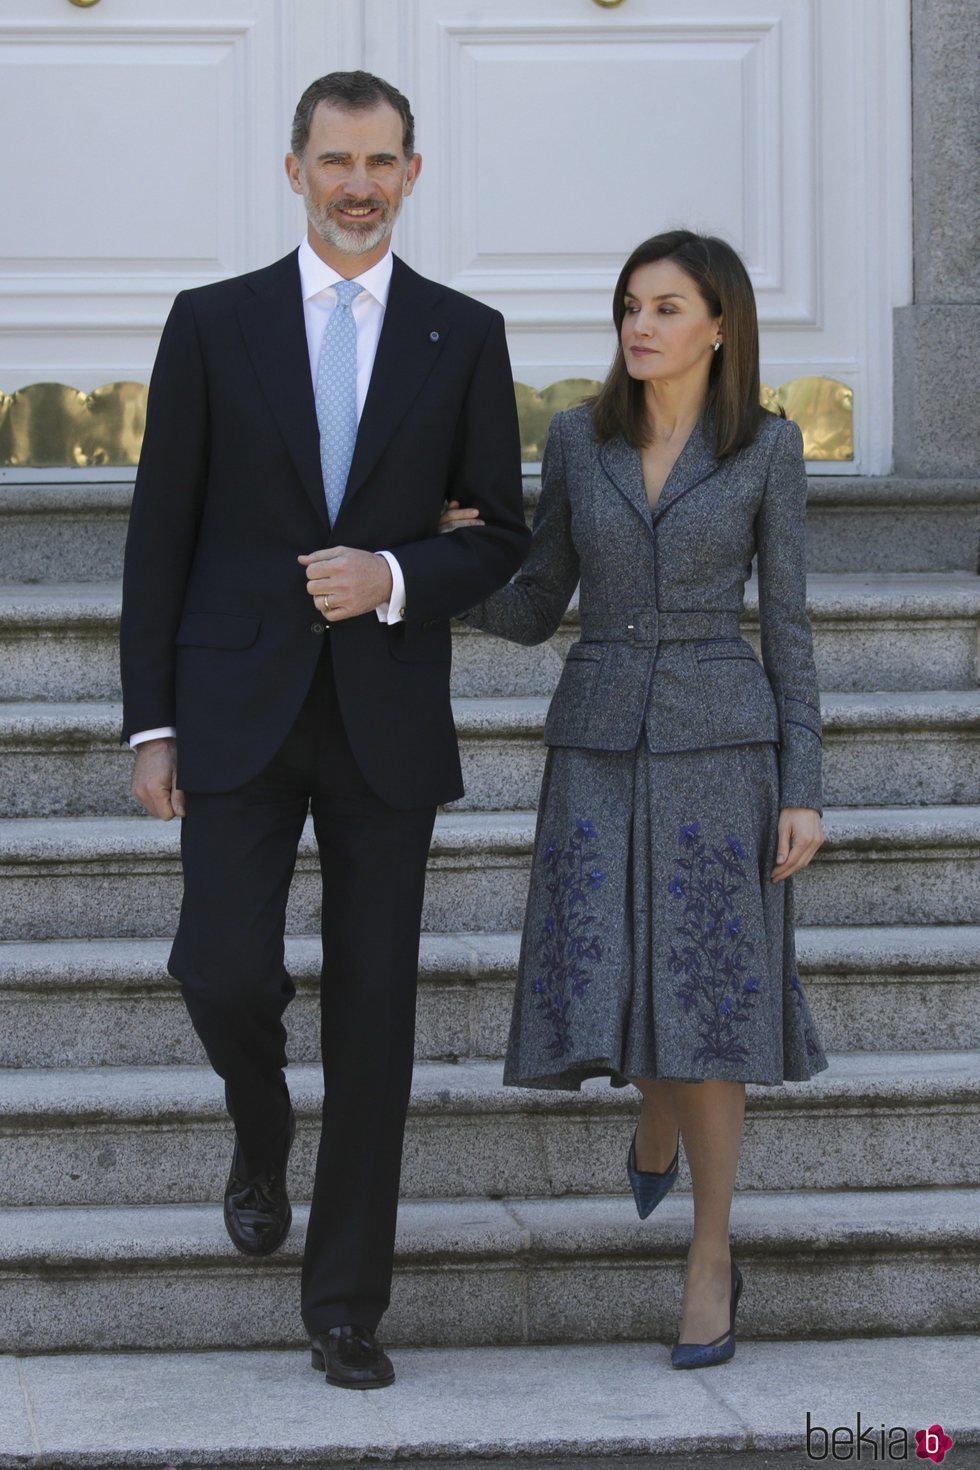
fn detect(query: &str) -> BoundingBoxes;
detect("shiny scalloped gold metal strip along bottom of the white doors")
[0,378,854,469]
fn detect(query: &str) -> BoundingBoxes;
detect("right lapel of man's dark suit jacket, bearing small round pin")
[338,256,447,519]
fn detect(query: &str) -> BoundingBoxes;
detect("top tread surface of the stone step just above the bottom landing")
[0,1188,980,1279]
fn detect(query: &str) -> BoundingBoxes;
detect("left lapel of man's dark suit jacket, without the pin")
[238,251,329,529]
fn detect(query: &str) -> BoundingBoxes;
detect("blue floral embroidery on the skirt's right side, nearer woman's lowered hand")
[667,822,760,1063]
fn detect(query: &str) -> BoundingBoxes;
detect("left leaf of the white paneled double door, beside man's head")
[0,0,302,391]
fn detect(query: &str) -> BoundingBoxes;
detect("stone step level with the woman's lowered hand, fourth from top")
[0,806,980,939]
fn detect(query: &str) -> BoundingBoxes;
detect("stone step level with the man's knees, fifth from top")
[0,925,980,1067]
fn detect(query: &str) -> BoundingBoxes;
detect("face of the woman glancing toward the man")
[620,260,721,382]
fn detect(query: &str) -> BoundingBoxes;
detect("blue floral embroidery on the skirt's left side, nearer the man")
[533,817,605,1057]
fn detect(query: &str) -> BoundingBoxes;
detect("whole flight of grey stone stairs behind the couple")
[0,476,980,1466]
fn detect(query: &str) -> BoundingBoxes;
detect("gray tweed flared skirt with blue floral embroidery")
[504,741,827,1089]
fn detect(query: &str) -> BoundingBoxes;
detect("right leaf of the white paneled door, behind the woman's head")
[363,0,911,473]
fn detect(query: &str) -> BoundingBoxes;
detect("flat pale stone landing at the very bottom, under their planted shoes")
[7,1340,980,1470]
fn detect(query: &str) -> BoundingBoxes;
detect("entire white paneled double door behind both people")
[0,0,911,473]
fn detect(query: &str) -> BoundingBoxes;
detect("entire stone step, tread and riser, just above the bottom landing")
[0,1189,980,1346]
